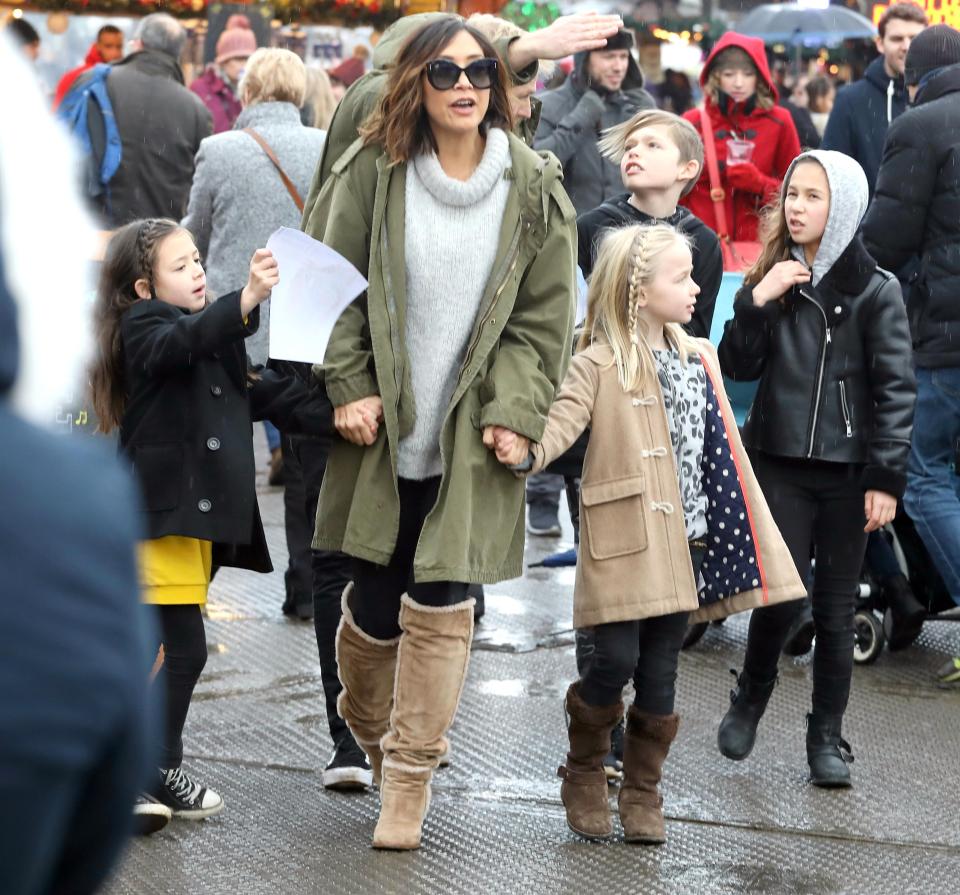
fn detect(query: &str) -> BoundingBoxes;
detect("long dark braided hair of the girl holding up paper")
[90,218,183,432]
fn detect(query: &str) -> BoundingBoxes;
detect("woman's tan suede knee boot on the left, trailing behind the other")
[336,583,400,786]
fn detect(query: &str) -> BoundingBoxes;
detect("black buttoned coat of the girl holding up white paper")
[120,292,332,572]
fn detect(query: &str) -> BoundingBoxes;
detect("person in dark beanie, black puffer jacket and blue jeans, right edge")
[863,25,960,673]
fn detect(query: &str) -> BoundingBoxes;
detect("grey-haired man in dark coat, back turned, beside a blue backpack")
[86,13,213,229]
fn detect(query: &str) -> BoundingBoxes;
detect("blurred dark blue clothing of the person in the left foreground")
[0,250,157,895]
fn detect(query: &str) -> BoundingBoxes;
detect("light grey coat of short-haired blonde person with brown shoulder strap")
[183,103,326,364]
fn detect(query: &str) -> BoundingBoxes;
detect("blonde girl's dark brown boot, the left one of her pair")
[557,683,623,839]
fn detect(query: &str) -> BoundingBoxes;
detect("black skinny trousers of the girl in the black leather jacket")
[744,453,867,715]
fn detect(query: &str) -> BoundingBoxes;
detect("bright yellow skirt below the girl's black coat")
[138,535,213,606]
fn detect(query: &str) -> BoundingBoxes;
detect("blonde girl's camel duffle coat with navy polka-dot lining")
[532,339,806,628]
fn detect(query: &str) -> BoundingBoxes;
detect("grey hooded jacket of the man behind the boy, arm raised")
[533,53,656,214]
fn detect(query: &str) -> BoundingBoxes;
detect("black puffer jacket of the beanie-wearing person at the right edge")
[863,65,960,367]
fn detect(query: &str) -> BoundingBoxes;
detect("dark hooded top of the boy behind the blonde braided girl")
[577,193,723,339]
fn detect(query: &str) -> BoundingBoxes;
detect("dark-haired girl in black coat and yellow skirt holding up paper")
[92,219,332,819]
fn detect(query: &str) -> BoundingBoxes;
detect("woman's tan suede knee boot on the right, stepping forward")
[373,594,474,849]
